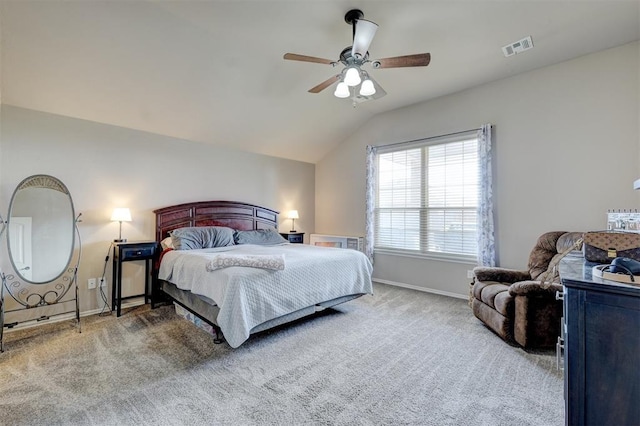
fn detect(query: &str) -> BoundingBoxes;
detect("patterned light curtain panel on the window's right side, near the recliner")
[478,124,496,266]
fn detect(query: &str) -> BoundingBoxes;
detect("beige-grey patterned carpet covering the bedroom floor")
[0,285,564,426]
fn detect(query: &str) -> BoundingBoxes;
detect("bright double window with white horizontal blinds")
[373,132,479,260]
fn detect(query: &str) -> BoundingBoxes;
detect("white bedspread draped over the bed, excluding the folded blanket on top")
[158,244,373,348]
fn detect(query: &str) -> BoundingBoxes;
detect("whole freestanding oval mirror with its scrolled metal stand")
[0,175,82,352]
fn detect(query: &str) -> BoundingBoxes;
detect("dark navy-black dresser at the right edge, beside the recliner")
[560,263,640,425]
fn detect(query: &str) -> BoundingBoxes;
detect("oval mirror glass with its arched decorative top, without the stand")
[7,175,75,284]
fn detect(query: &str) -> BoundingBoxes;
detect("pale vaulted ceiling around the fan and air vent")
[0,0,640,163]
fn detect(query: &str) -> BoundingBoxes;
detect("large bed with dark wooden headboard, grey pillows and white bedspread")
[151,201,373,348]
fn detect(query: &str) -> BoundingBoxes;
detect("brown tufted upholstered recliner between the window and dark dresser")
[471,231,582,348]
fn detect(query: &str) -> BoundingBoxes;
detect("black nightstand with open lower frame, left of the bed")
[111,241,158,316]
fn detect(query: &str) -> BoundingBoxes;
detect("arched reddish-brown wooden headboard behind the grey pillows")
[153,201,278,242]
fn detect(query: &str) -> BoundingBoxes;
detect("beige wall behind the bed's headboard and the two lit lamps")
[0,105,315,311]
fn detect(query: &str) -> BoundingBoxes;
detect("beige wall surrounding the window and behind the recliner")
[316,42,640,297]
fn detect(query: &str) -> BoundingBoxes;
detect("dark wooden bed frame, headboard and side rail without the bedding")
[151,201,278,343]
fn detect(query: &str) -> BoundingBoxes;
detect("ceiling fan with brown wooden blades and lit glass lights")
[284,9,431,106]
